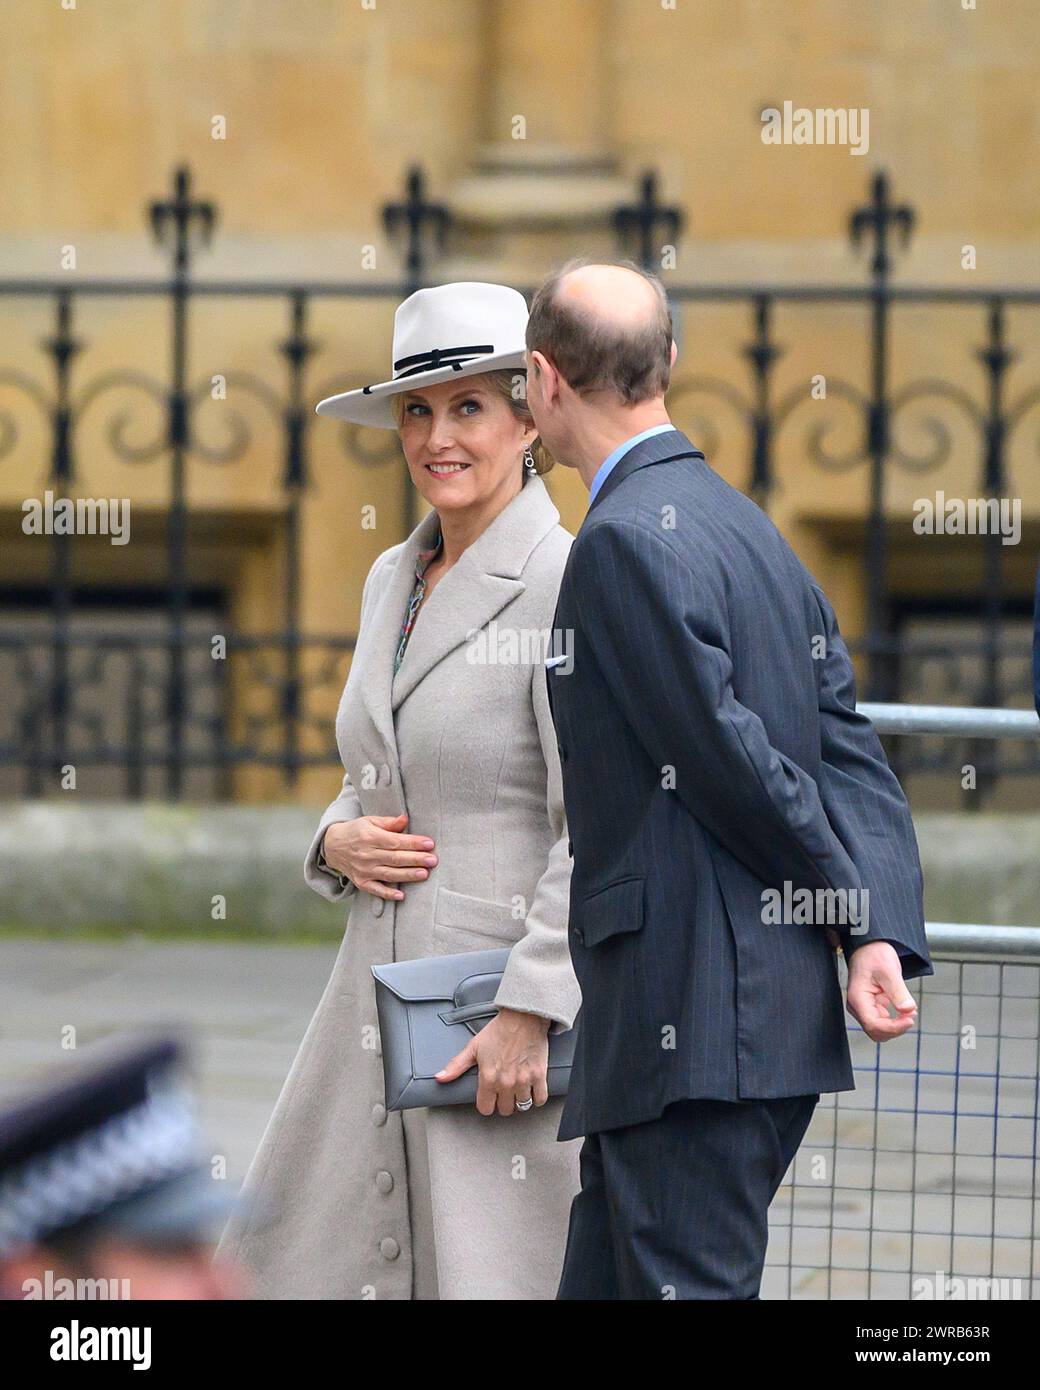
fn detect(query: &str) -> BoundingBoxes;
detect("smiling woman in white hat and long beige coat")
[220,284,580,1298]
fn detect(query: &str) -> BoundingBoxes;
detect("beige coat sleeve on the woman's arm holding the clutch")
[495,644,581,1033]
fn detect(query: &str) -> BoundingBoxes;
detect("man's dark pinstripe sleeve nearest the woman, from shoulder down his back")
[571,521,859,891]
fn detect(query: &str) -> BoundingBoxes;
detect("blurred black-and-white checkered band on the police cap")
[0,1088,197,1258]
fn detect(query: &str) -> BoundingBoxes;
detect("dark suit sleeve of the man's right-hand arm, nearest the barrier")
[813,587,933,980]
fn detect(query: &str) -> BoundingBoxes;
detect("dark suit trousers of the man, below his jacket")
[556,1095,819,1300]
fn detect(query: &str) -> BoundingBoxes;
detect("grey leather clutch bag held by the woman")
[373,947,576,1111]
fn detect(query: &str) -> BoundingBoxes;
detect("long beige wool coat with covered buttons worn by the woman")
[218,475,580,1298]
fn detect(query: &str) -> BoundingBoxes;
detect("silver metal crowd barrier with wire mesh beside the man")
[762,705,1040,1302]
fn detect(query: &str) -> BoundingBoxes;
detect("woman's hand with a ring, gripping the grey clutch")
[437,1009,551,1115]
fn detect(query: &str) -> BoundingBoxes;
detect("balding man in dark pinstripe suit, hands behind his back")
[527,263,932,1298]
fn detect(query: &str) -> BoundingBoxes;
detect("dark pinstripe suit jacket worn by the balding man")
[546,431,932,1138]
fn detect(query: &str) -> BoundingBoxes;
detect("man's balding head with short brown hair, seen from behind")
[527,260,672,404]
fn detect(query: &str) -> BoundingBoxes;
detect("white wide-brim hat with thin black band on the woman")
[314,281,527,430]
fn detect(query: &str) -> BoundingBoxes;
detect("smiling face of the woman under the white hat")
[398,375,535,510]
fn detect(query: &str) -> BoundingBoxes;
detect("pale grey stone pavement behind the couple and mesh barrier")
[0,937,1040,1300]
